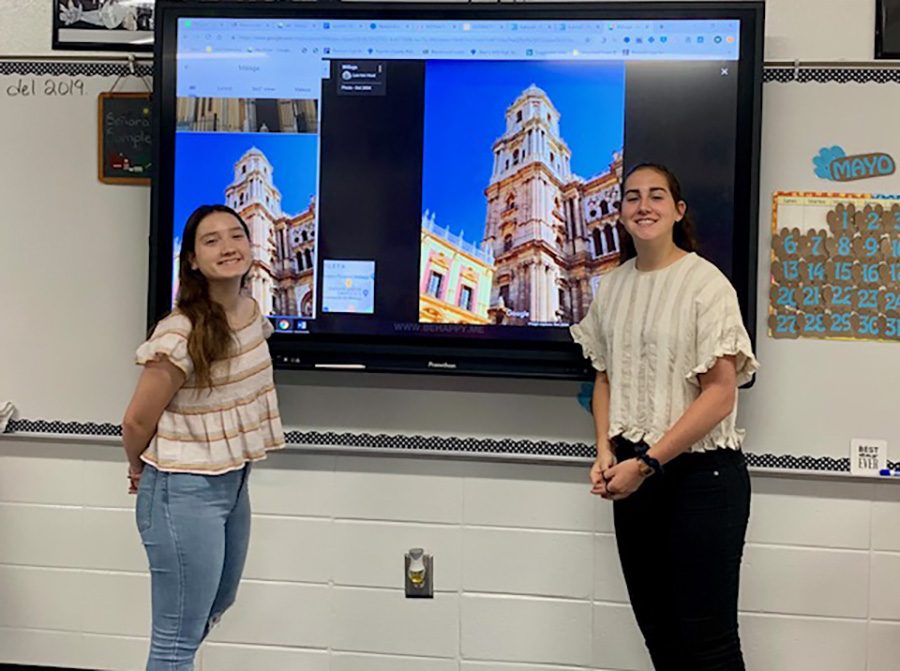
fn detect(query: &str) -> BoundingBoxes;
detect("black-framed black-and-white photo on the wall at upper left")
[52,0,156,51]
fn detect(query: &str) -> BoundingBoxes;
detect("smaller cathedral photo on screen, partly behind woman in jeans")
[172,125,319,317]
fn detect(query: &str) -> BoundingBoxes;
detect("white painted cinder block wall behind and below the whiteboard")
[0,0,900,671]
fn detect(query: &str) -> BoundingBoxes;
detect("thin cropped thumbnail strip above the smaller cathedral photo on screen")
[175,97,319,133]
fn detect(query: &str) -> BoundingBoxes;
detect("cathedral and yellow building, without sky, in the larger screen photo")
[419,84,624,325]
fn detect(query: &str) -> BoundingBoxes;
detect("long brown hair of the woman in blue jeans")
[175,205,250,389]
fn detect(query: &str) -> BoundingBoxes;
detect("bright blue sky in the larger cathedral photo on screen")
[422,61,625,244]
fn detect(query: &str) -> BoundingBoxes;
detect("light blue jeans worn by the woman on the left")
[136,464,250,671]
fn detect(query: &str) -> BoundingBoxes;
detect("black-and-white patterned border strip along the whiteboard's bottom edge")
[4,419,900,473]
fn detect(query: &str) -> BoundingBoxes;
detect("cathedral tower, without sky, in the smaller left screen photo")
[225,147,316,317]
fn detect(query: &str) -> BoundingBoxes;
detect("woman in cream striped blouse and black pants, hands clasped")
[571,164,758,671]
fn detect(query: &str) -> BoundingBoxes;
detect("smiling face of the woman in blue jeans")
[191,212,252,282]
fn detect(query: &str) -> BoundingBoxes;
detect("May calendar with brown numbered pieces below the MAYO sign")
[769,192,900,342]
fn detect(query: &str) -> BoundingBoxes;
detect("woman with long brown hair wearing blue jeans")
[122,205,284,671]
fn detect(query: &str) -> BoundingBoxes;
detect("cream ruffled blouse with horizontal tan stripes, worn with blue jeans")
[136,306,285,475]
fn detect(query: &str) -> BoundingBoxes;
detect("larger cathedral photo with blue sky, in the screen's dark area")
[419,62,624,326]
